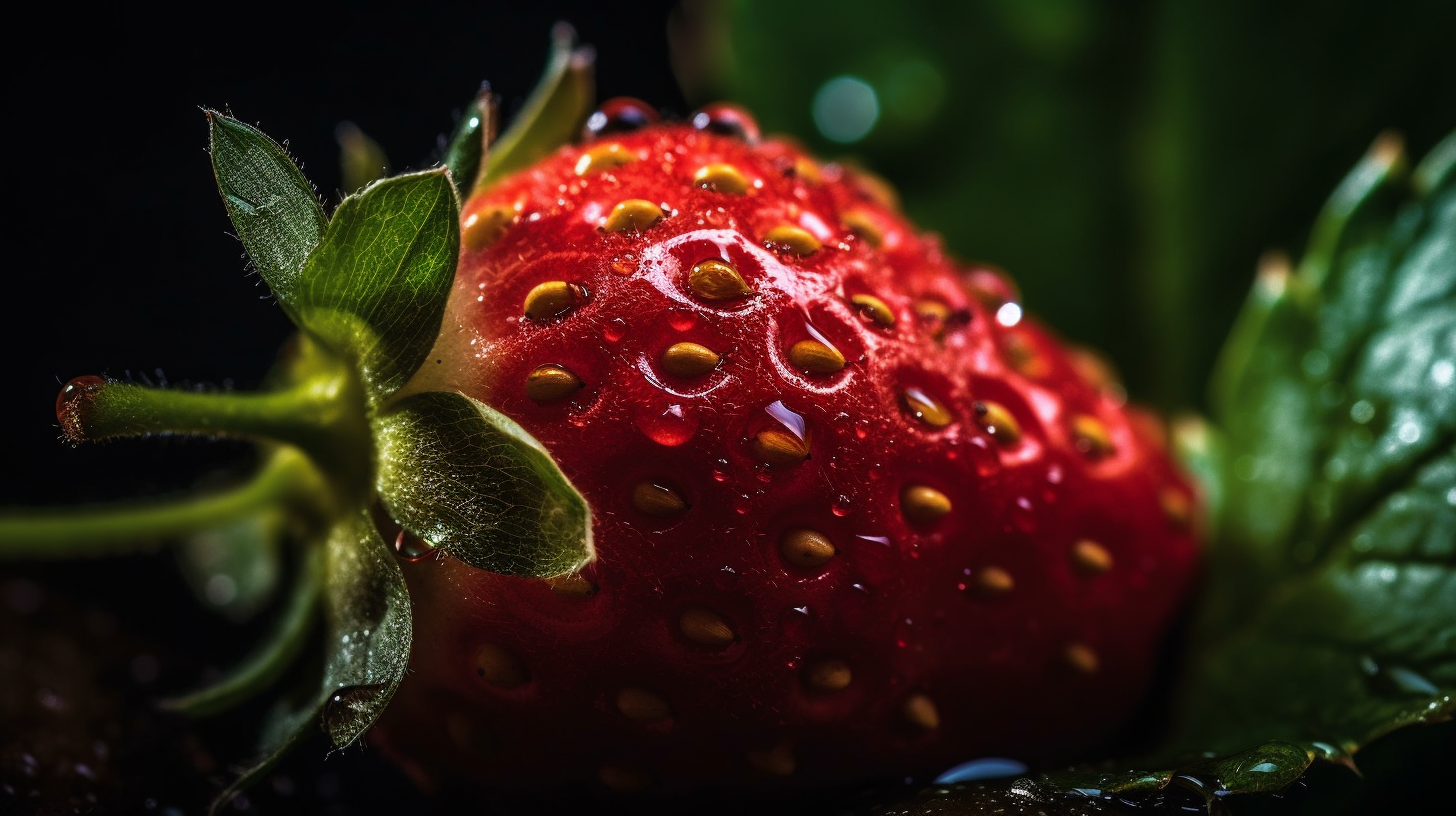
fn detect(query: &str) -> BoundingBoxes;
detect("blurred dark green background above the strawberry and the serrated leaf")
[674,0,1456,409]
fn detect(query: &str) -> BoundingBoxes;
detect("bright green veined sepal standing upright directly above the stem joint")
[287,169,460,402]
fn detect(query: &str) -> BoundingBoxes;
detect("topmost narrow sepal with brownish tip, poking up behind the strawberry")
[473,23,596,191]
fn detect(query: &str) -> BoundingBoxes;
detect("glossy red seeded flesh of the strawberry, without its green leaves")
[371,101,1197,790]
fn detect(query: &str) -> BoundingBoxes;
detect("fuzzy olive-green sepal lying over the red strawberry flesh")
[376,392,594,577]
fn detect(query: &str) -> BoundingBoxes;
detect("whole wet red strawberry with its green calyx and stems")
[0,32,1197,799]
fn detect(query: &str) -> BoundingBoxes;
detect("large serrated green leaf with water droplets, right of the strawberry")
[1174,137,1456,757]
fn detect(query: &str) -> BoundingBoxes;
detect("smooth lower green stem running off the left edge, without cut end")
[0,447,333,560]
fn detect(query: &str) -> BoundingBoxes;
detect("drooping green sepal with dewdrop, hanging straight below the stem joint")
[211,510,412,813]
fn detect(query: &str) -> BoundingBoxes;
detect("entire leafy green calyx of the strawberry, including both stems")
[0,26,594,807]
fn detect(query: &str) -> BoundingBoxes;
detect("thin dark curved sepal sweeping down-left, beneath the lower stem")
[162,546,326,717]
